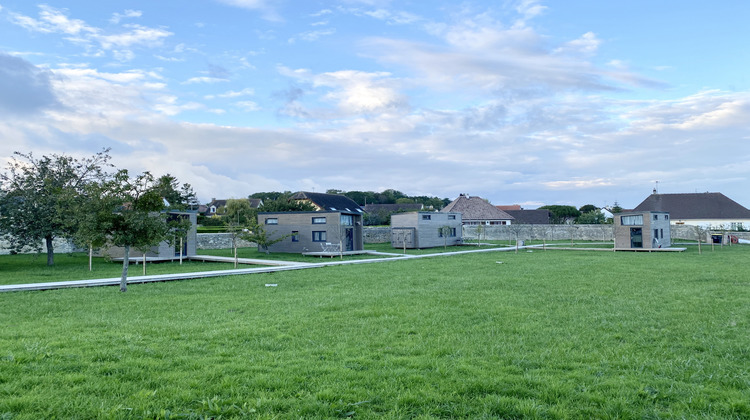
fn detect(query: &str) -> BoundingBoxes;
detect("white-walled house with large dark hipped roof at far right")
[633,192,750,230]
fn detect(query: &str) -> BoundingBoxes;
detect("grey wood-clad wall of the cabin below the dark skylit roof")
[258,211,364,253]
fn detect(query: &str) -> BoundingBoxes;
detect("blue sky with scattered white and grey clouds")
[0,0,750,209]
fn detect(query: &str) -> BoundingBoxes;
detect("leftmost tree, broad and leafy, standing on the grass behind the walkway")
[0,149,111,265]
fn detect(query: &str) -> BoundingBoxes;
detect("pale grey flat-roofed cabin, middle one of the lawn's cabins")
[391,211,463,249]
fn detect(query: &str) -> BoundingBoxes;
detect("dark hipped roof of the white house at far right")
[633,192,750,220]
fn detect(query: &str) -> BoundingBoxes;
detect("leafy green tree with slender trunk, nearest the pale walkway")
[79,169,174,292]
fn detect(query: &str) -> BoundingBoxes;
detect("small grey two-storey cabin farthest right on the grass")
[614,211,672,250]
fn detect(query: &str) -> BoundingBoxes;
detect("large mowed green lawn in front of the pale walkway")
[0,246,750,419]
